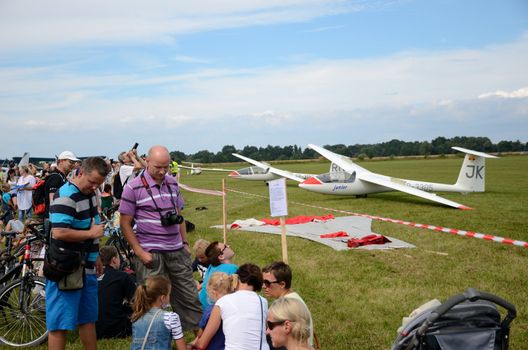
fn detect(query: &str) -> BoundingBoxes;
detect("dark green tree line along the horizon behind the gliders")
[171,136,528,163]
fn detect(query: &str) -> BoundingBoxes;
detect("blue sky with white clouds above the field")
[0,0,528,159]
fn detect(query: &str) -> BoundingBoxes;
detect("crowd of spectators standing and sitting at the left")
[0,146,318,350]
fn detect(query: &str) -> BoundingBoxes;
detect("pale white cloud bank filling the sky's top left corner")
[0,0,366,51]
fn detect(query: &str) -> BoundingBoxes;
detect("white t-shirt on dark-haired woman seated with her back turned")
[215,290,269,350]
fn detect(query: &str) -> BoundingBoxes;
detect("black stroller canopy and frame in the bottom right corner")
[392,288,517,350]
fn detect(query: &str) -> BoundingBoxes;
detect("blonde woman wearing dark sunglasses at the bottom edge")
[266,298,311,350]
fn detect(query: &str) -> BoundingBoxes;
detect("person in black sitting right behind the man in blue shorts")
[95,246,136,339]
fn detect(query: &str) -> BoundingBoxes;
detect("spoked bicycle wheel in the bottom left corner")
[0,276,48,347]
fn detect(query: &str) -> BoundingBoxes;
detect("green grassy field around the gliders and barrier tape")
[20,156,528,349]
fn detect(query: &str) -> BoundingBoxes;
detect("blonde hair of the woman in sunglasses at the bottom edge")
[268,297,311,344]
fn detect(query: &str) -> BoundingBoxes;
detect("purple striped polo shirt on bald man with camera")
[119,170,183,251]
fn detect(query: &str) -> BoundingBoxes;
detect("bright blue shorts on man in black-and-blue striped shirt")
[46,274,98,331]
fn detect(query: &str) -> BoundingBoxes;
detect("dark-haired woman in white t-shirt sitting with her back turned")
[194,263,269,350]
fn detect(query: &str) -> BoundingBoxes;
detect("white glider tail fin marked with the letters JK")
[453,147,497,192]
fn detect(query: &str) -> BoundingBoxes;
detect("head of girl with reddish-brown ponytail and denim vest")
[131,275,171,322]
